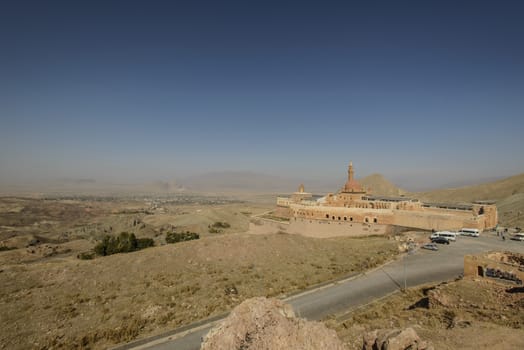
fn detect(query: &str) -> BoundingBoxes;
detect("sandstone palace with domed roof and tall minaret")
[275,163,498,236]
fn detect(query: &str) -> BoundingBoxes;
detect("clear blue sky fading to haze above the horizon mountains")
[0,0,524,191]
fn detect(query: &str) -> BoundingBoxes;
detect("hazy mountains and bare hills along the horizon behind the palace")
[0,171,524,227]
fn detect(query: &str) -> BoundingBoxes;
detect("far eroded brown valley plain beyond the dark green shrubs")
[0,195,273,263]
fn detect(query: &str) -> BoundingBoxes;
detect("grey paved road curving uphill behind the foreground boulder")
[116,233,524,350]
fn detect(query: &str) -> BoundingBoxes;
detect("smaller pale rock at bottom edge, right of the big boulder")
[362,328,434,350]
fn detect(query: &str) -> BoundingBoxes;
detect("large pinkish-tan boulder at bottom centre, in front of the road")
[201,297,345,350]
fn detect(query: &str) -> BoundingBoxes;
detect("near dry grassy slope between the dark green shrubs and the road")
[0,234,397,349]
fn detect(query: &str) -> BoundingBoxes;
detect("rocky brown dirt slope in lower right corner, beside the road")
[326,279,524,350]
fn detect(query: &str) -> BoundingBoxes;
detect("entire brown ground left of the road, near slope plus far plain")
[0,198,398,349]
